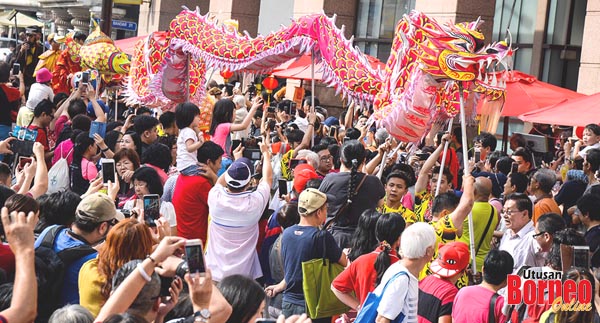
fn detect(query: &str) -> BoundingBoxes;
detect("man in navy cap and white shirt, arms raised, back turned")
[206,143,273,281]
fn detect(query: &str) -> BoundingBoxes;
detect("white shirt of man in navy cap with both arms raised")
[206,181,271,281]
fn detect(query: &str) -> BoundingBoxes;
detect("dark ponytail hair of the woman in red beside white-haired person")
[374,213,406,287]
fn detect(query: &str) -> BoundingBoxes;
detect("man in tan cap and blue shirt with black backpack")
[35,193,123,306]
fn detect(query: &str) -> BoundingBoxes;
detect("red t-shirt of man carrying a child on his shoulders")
[172,175,212,242]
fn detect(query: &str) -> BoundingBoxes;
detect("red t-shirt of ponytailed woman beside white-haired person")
[328,248,399,304]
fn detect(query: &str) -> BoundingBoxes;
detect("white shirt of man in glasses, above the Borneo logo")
[499,221,539,274]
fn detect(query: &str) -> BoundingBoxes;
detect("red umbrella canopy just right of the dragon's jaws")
[477,71,584,117]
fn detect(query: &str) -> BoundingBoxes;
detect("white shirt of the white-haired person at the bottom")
[374,261,419,323]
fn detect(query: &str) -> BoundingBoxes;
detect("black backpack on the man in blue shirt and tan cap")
[35,225,96,323]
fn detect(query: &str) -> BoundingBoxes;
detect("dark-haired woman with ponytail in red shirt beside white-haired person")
[331,213,406,311]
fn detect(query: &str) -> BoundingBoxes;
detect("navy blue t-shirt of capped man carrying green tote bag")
[281,224,342,306]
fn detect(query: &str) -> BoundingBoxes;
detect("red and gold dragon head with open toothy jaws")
[409,13,513,95]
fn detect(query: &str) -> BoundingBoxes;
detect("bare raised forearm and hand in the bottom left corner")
[0,207,38,323]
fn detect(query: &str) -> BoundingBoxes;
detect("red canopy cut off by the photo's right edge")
[519,93,600,127]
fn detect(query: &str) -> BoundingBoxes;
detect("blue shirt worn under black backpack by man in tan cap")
[34,225,98,306]
